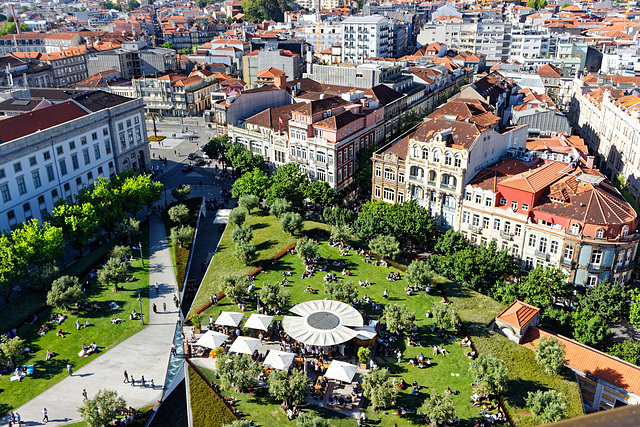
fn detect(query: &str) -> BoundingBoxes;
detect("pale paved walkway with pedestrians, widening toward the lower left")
[0,219,178,426]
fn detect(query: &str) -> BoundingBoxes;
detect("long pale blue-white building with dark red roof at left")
[0,91,150,230]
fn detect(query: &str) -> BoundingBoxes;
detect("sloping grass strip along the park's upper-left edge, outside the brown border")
[189,209,331,315]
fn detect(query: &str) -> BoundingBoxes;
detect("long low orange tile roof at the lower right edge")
[523,327,640,395]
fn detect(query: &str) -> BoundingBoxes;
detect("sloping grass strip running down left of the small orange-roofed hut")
[442,280,583,426]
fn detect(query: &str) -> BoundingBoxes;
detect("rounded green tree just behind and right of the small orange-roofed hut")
[518,266,571,310]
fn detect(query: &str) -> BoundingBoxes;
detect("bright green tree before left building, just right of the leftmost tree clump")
[52,202,98,251]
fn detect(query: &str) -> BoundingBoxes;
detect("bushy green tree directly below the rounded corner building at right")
[578,280,629,322]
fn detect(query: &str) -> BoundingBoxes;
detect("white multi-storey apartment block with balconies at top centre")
[342,15,394,63]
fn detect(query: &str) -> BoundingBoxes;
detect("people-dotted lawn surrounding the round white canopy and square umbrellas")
[198,239,488,426]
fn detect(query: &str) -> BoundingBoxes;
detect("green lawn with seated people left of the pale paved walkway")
[0,226,149,415]
